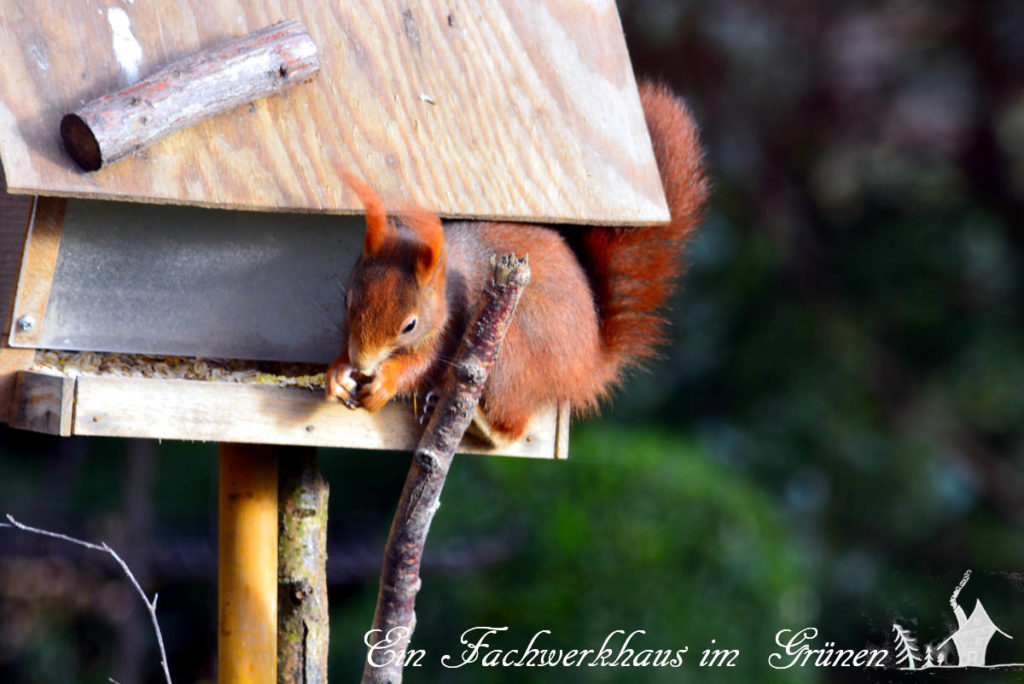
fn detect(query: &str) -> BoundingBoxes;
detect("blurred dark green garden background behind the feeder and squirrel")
[0,0,1024,683]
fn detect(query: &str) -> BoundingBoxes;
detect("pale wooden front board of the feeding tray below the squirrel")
[64,376,558,459]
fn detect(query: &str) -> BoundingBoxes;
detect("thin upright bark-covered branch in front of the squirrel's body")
[362,254,529,684]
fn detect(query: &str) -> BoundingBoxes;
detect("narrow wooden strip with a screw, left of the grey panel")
[9,198,68,347]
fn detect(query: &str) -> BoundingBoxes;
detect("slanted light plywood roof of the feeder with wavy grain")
[0,0,668,224]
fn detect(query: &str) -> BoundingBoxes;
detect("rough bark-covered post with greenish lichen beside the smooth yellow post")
[278,446,330,684]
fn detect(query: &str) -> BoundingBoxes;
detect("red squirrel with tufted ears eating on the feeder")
[327,83,708,442]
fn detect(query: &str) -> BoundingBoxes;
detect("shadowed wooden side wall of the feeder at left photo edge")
[0,188,35,423]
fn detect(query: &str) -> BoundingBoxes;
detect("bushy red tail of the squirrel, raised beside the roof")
[582,82,708,384]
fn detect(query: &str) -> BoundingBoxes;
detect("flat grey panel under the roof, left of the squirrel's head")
[39,200,364,364]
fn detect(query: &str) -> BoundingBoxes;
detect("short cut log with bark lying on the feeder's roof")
[60,19,319,171]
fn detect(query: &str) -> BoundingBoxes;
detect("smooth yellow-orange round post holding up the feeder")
[217,444,278,684]
